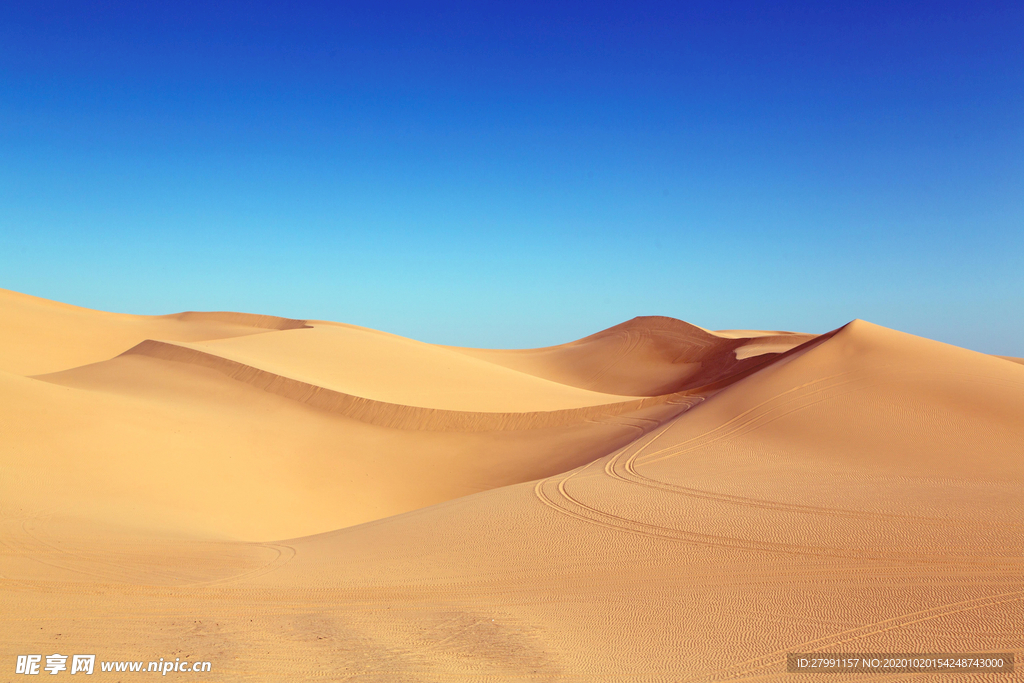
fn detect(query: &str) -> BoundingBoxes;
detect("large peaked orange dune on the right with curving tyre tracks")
[232,322,1024,681]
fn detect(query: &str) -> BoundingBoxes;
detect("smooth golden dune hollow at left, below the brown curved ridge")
[6,354,686,540]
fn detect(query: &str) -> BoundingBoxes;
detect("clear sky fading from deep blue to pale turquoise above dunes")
[0,0,1024,355]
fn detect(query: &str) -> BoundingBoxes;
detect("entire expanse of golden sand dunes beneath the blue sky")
[0,290,1024,683]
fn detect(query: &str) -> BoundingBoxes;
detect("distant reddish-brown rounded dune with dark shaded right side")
[452,316,814,396]
